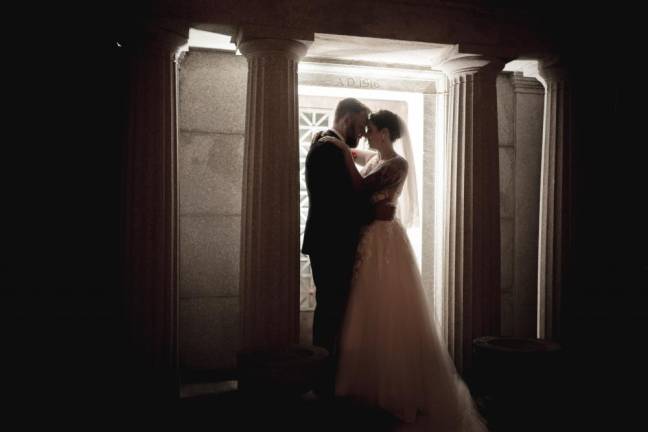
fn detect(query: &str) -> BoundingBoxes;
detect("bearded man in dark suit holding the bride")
[302,98,394,396]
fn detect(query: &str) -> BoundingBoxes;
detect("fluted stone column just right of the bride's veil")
[440,55,504,370]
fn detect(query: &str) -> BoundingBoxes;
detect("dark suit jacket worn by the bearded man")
[302,130,373,255]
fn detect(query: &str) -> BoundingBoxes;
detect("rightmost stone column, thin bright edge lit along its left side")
[538,59,573,340]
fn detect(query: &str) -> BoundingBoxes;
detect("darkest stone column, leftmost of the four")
[123,22,188,398]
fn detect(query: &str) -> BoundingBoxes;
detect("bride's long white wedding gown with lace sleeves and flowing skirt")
[336,156,487,432]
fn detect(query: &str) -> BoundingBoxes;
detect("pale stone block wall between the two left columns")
[178,50,247,369]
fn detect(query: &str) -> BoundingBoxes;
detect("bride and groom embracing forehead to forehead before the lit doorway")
[302,98,487,432]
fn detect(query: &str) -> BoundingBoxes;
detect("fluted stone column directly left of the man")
[239,39,306,349]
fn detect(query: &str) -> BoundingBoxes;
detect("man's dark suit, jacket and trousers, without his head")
[302,130,373,392]
